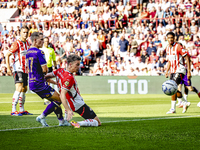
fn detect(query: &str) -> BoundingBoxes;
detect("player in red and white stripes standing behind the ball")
[165,32,191,114]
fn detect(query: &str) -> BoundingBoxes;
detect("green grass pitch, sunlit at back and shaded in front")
[0,94,200,150]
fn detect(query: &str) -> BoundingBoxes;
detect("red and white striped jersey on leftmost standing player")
[9,40,30,73]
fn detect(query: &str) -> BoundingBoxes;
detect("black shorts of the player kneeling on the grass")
[75,104,97,119]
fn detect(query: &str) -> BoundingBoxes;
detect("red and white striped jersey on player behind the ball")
[166,43,187,73]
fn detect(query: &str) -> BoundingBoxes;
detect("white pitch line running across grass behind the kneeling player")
[0,115,200,132]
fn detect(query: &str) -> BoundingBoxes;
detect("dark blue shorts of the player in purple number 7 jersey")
[33,85,55,99]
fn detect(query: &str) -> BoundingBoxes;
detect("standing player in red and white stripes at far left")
[6,26,32,116]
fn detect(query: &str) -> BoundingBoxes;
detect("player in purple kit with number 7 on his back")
[26,32,73,127]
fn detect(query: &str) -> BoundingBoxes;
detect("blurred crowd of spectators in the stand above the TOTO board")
[0,0,200,76]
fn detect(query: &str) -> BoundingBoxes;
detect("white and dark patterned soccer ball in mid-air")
[162,80,178,96]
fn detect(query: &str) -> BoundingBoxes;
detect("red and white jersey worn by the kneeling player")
[53,68,85,111]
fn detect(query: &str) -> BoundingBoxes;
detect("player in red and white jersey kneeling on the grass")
[45,54,101,128]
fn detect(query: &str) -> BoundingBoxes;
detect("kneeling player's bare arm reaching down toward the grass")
[60,89,74,121]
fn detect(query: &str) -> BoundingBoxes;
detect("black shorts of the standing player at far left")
[13,71,28,86]
